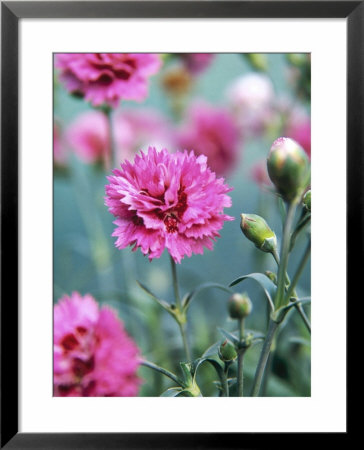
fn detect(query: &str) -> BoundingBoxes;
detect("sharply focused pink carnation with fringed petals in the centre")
[105,147,233,263]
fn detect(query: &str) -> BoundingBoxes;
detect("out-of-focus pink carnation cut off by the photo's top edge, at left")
[55,53,161,107]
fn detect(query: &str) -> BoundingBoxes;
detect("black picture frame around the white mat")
[1,1,356,449]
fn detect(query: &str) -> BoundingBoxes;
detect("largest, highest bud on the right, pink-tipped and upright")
[267,137,310,201]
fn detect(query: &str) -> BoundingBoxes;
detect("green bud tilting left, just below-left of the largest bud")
[240,214,277,253]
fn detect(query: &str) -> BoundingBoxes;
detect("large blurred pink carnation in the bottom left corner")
[53,292,140,397]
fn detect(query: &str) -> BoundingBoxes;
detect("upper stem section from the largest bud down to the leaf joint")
[275,200,297,309]
